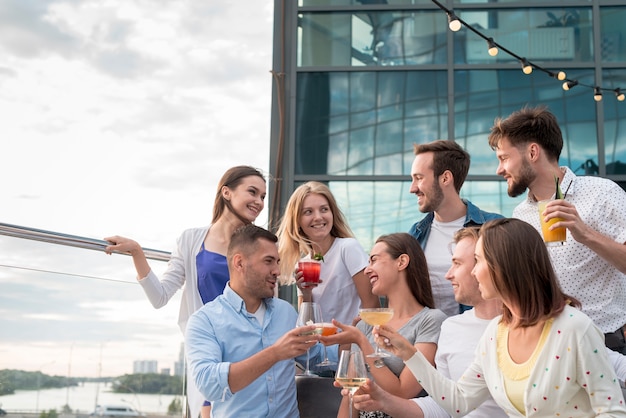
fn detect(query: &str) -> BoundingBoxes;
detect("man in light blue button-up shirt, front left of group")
[185,225,321,418]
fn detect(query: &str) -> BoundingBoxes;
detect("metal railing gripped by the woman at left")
[0,222,171,261]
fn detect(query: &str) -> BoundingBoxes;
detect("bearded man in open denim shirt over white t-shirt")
[409,140,502,316]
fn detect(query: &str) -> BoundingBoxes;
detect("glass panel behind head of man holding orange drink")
[454,70,598,175]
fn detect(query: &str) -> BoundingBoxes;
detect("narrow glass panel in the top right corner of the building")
[600,7,626,62]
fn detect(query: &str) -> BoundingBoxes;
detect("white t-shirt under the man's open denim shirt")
[424,216,465,316]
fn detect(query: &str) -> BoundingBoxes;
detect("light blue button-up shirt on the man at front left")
[185,284,314,418]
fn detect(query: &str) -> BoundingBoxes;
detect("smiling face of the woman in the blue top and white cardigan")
[222,176,267,222]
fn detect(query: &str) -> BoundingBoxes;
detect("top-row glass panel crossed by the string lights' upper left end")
[454,7,588,63]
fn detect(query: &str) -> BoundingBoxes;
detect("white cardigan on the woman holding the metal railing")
[139,226,210,418]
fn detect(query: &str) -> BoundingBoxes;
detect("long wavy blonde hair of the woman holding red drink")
[277,181,354,284]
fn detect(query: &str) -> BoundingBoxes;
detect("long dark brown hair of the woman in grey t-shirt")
[376,232,435,309]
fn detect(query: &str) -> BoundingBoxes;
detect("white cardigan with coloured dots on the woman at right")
[406,306,626,418]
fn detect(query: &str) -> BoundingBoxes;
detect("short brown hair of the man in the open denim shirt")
[413,139,470,193]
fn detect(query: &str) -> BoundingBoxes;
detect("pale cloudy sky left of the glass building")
[0,0,273,377]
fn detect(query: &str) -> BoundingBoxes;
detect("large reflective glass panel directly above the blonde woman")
[295,71,448,176]
